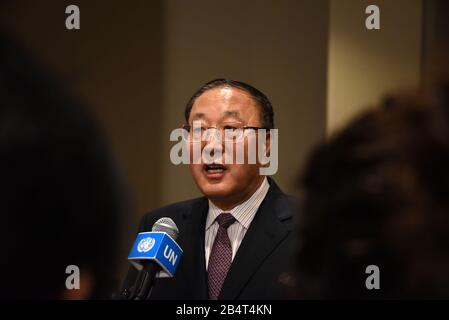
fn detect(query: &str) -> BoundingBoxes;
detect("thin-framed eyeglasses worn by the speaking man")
[182,123,266,142]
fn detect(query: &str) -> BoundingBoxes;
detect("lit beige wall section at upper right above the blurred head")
[326,0,423,134]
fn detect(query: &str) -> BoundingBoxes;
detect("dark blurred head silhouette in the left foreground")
[0,34,122,299]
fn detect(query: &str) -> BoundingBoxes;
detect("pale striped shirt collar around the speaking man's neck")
[206,177,270,230]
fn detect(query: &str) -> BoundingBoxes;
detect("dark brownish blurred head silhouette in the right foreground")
[297,82,449,299]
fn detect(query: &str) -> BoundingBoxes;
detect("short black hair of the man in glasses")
[184,79,274,129]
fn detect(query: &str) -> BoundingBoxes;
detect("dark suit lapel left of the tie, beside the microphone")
[183,198,209,299]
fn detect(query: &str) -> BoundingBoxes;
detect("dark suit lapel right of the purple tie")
[219,179,291,300]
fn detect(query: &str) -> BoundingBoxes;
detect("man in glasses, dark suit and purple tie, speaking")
[117,79,295,300]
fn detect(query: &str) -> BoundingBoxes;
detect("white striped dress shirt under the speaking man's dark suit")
[204,178,270,270]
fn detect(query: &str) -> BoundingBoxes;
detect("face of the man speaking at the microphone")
[189,87,263,205]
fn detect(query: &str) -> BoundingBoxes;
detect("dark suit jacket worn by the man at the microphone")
[118,178,295,300]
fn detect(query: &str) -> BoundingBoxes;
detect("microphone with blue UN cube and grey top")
[128,217,183,300]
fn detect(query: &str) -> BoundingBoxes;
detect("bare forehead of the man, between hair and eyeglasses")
[190,86,260,122]
